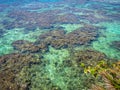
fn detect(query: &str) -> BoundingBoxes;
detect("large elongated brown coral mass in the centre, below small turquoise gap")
[35,25,99,48]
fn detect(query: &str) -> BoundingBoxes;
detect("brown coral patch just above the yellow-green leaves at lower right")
[66,50,107,66]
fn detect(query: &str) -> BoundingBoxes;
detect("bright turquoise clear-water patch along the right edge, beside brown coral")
[92,22,120,59]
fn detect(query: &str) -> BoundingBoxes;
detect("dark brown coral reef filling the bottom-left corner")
[0,53,41,90]
